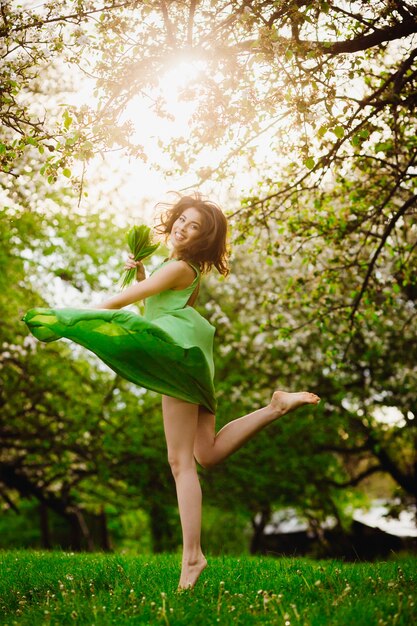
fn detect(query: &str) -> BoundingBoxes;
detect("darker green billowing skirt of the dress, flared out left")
[23,308,216,413]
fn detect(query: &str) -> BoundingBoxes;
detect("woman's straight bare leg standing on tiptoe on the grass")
[162,396,207,589]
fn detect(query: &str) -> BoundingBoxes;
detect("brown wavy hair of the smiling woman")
[155,192,229,276]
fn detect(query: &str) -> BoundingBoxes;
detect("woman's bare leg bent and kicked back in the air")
[194,391,320,467]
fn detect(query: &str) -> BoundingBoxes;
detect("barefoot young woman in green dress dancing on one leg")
[24,194,319,589]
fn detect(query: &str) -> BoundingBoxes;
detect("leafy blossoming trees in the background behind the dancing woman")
[0,0,417,549]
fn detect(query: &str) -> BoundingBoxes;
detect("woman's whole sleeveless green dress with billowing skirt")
[23,259,216,413]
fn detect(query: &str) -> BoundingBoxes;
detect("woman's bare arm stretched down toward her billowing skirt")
[94,261,194,309]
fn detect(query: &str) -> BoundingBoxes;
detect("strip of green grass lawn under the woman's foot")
[0,551,417,626]
